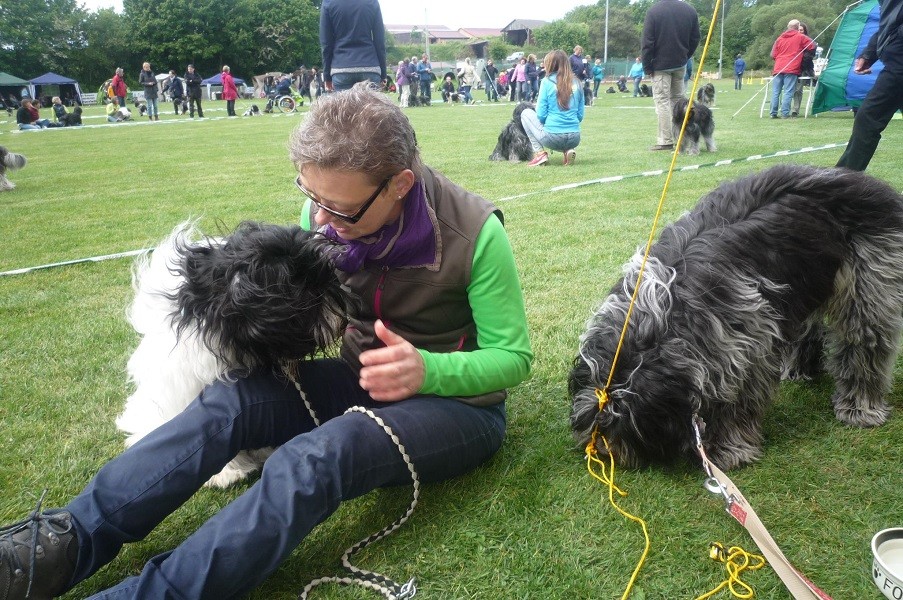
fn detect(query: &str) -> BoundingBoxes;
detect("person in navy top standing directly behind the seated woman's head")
[320,0,386,92]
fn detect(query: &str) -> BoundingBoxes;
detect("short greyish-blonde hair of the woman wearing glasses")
[289,82,423,184]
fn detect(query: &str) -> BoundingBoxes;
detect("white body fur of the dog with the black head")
[116,223,273,487]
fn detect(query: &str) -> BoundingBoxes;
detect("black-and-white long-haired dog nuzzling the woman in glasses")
[122,222,353,487]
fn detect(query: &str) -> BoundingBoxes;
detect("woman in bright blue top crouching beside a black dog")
[520,50,584,167]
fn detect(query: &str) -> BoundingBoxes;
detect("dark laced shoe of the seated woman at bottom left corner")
[0,496,78,600]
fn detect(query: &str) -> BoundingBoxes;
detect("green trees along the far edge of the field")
[0,0,849,88]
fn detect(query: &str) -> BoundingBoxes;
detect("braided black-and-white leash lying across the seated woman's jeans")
[292,369,420,600]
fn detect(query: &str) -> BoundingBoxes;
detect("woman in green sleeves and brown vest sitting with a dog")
[0,83,533,600]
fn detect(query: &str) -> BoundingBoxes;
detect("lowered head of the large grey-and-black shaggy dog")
[568,257,695,468]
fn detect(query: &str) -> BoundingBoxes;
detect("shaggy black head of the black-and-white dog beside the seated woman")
[172,221,354,368]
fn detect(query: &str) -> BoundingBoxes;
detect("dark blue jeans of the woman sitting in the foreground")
[66,359,505,600]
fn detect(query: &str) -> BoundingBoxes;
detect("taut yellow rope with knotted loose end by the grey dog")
[586,0,728,600]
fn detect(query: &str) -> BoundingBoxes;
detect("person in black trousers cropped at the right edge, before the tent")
[837,0,903,171]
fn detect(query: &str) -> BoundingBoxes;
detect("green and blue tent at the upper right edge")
[812,0,884,114]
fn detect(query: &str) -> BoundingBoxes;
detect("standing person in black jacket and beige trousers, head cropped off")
[641,0,699,150]
